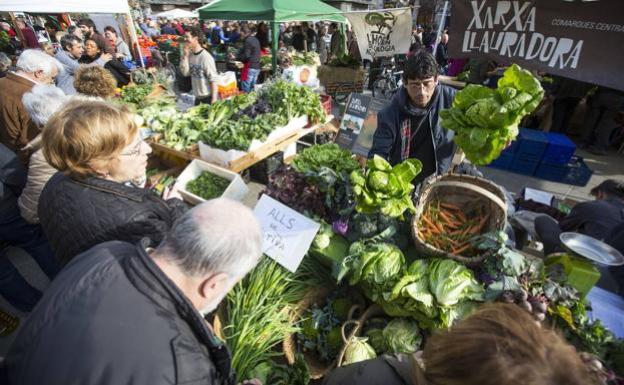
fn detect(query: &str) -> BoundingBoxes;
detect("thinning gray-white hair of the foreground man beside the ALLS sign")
[157,198,262,278]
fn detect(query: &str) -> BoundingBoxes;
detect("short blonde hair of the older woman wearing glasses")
[42,100,138,177]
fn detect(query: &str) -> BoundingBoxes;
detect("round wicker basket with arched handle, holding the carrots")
[412,174,507,266]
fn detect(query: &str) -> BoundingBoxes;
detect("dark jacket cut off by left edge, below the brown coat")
[0,143,27,222]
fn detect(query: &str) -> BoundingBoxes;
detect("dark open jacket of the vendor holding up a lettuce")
[368,84,457,173]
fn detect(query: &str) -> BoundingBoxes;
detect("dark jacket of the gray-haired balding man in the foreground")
[4,242,234,385]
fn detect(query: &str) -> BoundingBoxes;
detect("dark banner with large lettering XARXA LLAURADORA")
[448,0,624,90]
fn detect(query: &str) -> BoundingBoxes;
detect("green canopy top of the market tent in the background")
[197,0,346,23]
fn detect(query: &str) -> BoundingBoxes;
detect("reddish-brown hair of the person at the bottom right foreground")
[414,303,595,385]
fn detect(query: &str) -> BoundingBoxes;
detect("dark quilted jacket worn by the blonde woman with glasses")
[38,173,186,264]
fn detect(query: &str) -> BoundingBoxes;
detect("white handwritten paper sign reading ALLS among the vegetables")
[254,195,320,273]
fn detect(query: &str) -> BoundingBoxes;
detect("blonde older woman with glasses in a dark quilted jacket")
[38,101,186,264]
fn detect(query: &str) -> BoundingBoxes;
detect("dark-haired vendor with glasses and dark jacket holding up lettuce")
[368,51,456,184]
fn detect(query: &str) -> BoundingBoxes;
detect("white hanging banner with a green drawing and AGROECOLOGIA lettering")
[344,8,412,60]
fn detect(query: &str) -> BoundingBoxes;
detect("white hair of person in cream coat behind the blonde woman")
[22,84,68,127]
